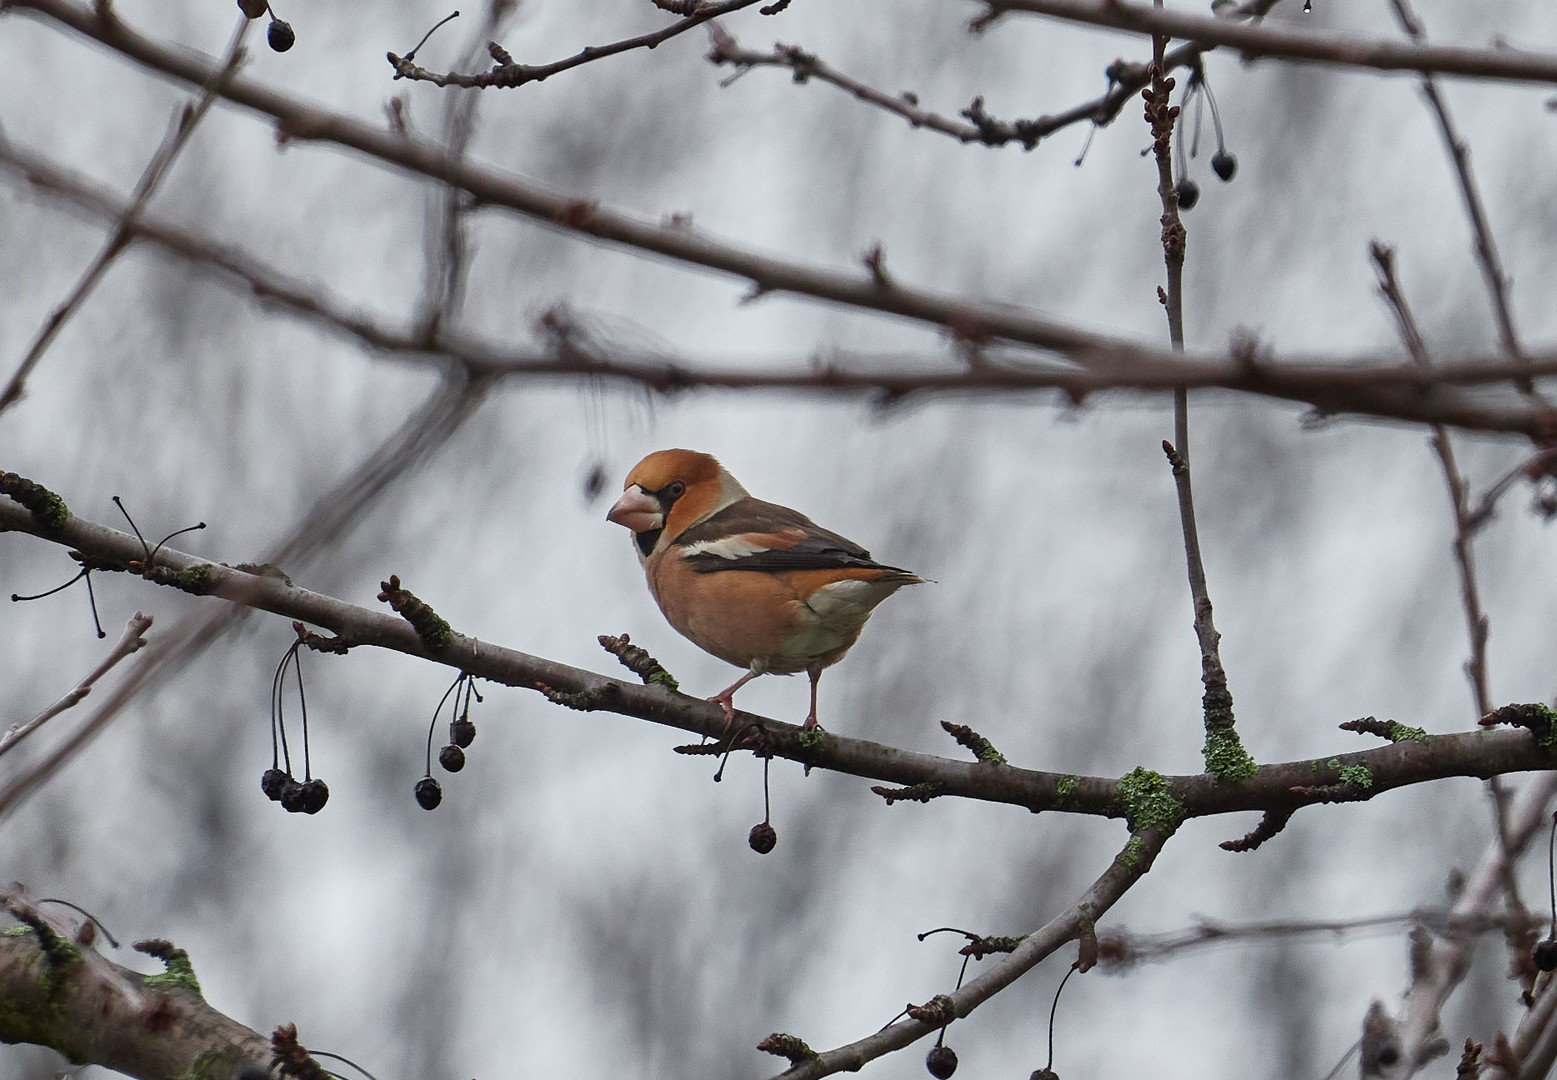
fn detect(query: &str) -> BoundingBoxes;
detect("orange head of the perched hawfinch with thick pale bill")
[606,450,747,559]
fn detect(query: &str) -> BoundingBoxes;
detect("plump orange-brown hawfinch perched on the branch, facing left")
[606,450,925,728]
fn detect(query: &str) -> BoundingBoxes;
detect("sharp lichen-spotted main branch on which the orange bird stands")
[9,498,1557,825]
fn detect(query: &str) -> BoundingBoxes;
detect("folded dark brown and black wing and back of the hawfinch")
[676,498,908,574]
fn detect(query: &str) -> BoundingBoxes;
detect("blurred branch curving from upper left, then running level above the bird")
[0,137,1557,437]
